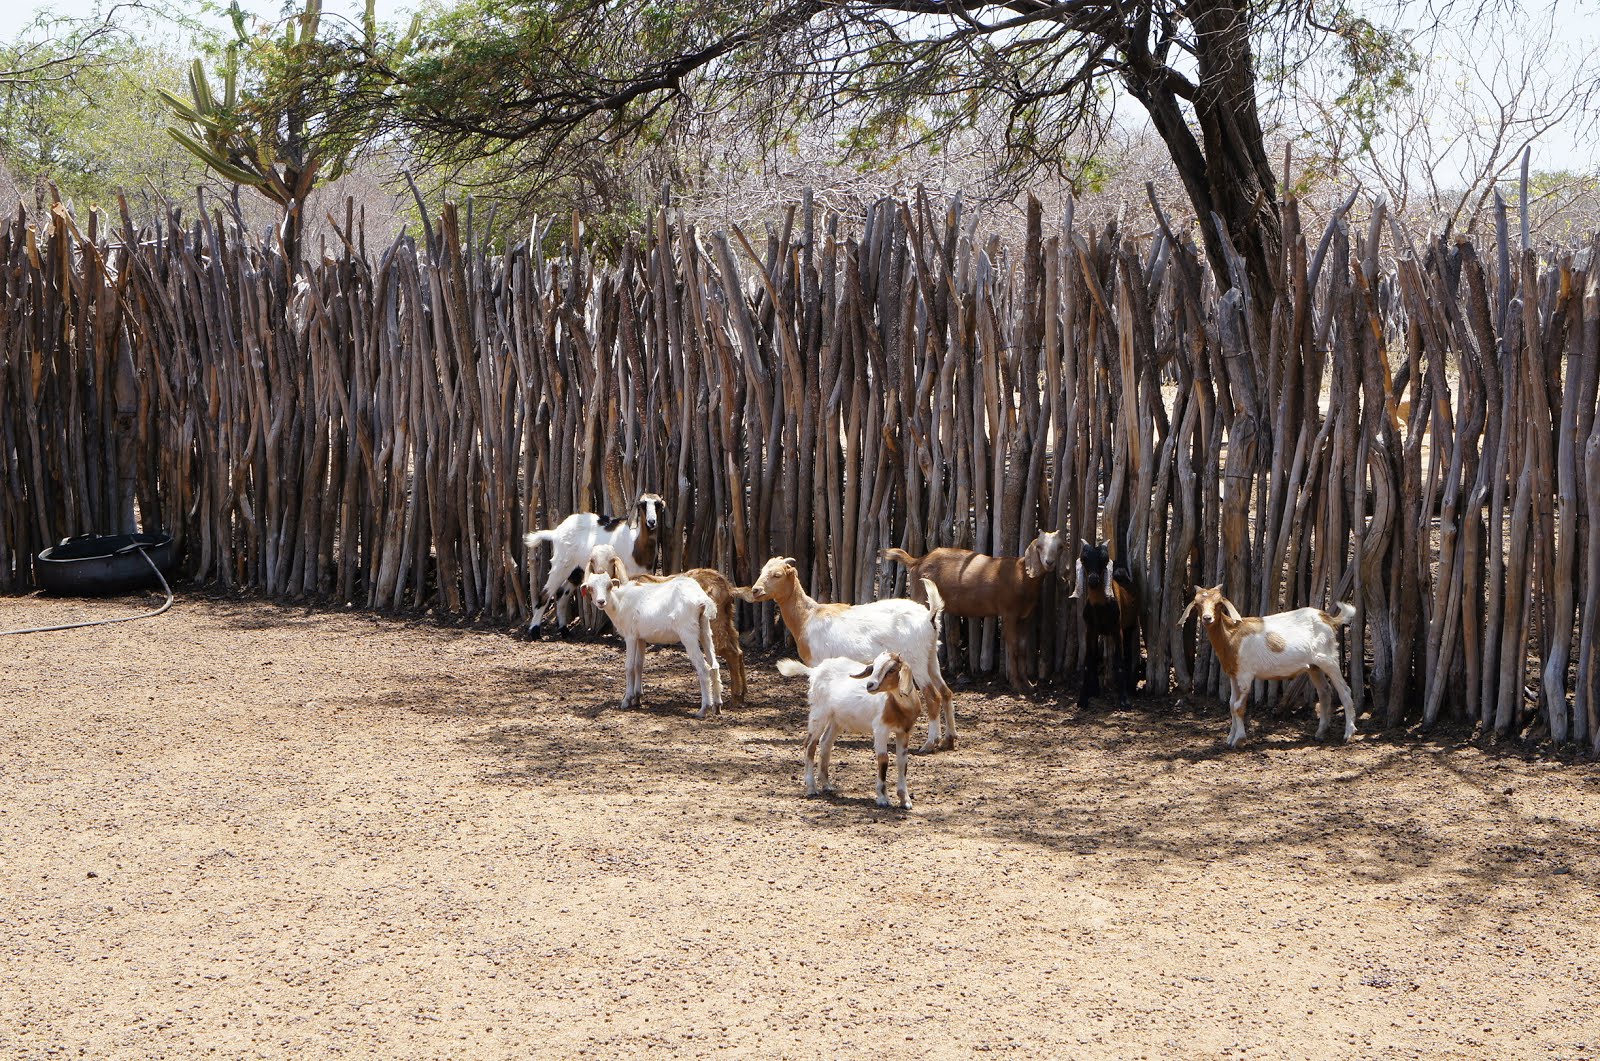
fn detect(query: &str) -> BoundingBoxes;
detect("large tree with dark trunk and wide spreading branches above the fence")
[363,0,1427,299]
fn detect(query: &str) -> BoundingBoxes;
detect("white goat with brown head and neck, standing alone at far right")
[1178,584,1355,747]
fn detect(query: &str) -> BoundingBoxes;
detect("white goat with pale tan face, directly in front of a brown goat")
[582,557,722,719]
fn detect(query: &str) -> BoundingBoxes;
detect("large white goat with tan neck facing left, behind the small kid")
[750,557,955,752]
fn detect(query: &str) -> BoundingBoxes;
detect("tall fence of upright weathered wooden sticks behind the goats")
[0,195,1600,749]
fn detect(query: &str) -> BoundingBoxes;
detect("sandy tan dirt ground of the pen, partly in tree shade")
[0,594,1600,1058]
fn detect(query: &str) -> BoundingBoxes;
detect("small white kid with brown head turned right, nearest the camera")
[778,651,922,810]
